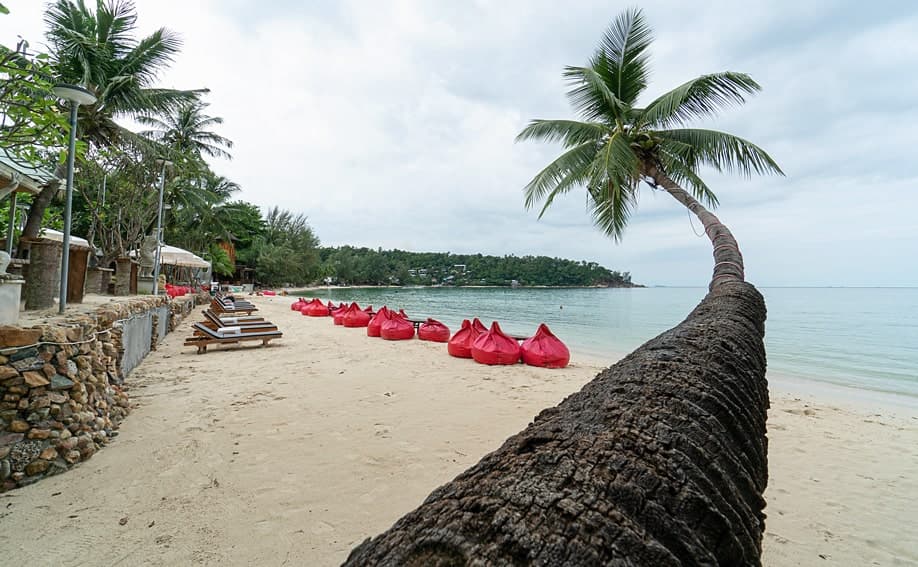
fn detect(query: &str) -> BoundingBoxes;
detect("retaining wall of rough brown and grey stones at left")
[0,296,210,492]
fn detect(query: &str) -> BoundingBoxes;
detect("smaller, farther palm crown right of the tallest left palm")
[137,100,233,159]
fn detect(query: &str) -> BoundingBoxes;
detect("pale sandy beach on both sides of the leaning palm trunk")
[0,297,918,565]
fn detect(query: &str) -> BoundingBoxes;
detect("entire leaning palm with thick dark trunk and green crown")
[346,11,780,566]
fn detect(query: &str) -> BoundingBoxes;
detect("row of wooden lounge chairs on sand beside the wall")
[185,296,284,354]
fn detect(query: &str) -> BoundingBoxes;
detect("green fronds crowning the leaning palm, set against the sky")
[517,10,783,240]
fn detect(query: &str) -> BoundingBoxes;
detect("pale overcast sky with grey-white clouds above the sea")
[0,0,918,286]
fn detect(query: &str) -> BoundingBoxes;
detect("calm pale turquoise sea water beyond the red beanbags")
[306,288,918,404]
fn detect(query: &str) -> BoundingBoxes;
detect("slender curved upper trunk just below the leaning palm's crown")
[645,166,745,290]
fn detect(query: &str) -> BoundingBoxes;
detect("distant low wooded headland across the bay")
[319,246,633,287]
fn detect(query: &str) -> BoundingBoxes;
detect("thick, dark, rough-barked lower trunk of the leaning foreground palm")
[346,278,769,566]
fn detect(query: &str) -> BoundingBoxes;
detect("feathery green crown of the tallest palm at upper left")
[45,0,206,149]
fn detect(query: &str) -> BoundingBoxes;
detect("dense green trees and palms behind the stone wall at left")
[0,0,320,284]
